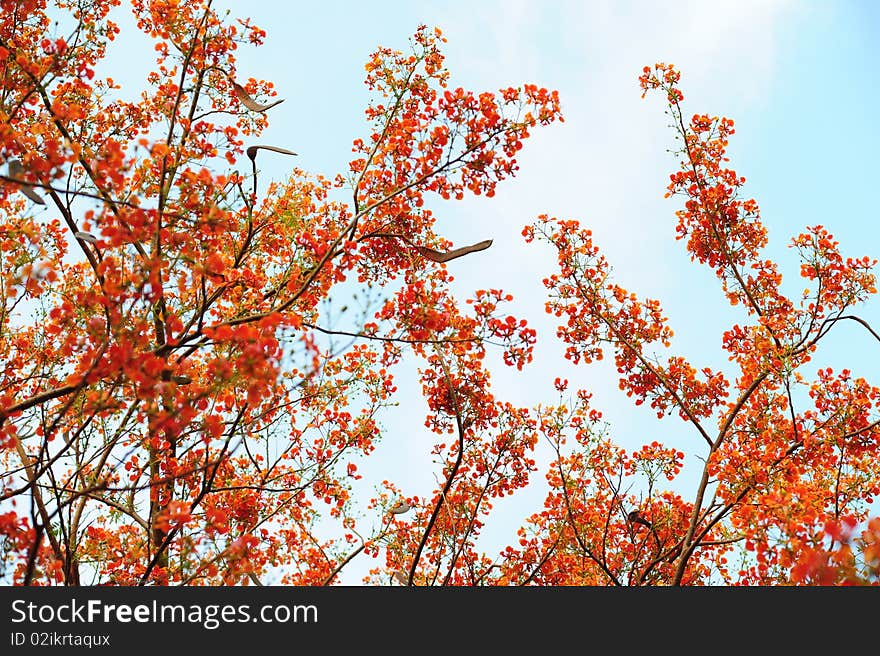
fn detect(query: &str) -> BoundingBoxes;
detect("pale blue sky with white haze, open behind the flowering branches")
[105,0,880,582]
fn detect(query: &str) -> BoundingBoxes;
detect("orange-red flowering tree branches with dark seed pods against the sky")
[0,0,880,585]
